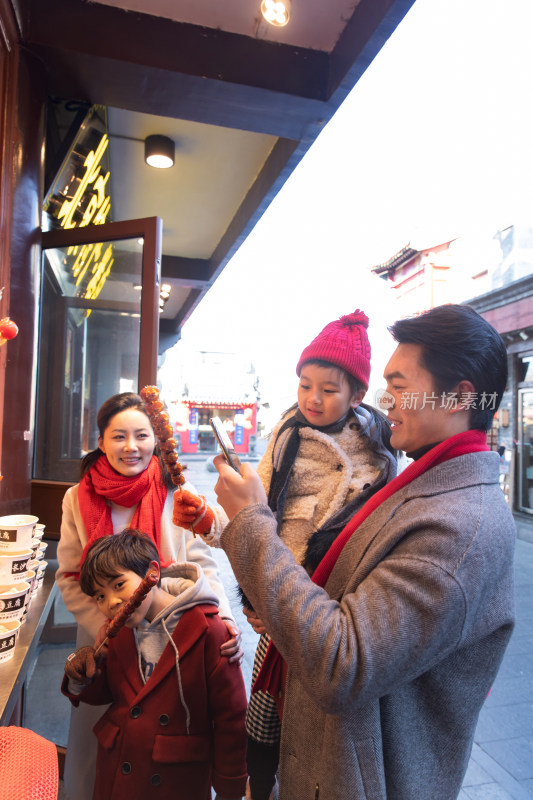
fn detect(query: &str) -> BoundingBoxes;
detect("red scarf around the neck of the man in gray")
[252,431,490,700]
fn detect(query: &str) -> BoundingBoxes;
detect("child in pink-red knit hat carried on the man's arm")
[174,309,396,800]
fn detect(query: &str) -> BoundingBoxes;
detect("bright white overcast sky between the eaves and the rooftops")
[160,0,533,418]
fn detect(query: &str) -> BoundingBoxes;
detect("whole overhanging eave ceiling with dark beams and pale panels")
[14,0,414,350]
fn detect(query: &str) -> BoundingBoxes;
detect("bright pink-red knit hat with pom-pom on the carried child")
[296,309,370,389]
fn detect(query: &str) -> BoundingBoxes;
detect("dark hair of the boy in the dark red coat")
[80,528,161,596]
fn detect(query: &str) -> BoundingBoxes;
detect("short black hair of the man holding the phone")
[389,304,507,431]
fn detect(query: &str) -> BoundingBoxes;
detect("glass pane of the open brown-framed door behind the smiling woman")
[34,234,143,481]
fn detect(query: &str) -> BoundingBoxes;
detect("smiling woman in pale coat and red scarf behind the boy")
[56,392,243,800]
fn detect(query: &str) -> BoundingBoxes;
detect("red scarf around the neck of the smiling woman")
[78,455,167,564]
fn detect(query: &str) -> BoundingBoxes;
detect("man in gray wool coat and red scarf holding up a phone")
[216,305,515,800]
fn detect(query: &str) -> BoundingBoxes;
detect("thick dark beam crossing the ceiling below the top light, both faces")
[19,0,329,138]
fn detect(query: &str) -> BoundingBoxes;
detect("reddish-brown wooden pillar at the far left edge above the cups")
[0,0,46,514]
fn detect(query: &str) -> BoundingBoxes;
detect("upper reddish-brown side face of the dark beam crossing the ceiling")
[24,0,328,100]
